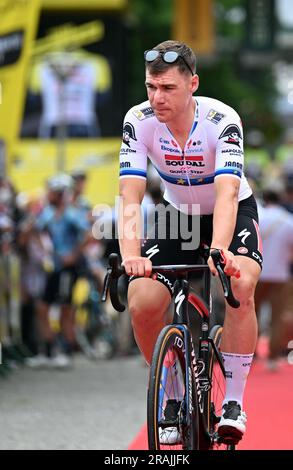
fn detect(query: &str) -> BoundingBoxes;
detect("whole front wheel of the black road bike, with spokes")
[147,325,199,450]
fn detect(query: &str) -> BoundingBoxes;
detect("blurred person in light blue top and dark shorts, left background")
[28,175,90,367]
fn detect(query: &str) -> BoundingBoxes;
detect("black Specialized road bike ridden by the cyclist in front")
[102,247,240,450]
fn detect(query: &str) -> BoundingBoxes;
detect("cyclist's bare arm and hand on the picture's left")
[118,178,152,276]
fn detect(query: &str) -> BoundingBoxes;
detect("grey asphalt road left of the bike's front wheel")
[0,356,147,450]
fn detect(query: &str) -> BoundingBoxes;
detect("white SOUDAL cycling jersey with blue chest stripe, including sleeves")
[120,96,252,215]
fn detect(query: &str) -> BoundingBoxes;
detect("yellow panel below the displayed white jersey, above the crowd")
[9,138,121,206]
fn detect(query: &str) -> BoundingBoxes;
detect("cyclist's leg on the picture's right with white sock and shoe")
[219,256,260,437]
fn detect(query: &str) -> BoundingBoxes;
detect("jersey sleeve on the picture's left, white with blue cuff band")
[120,110,147,179]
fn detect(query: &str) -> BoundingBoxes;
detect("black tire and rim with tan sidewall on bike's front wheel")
[147,325,199,450]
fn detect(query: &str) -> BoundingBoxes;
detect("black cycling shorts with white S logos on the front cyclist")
[130,195,262,294]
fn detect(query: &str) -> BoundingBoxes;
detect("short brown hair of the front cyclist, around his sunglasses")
[146,40,196,75]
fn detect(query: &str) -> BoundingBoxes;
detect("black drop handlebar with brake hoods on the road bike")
[102,250,240,312]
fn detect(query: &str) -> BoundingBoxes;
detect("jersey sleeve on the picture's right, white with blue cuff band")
[215,112,244,179]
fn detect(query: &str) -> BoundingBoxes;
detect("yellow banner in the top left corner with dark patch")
[0,0,40,168]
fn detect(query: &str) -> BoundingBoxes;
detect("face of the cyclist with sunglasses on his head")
[145,67,199,123]
